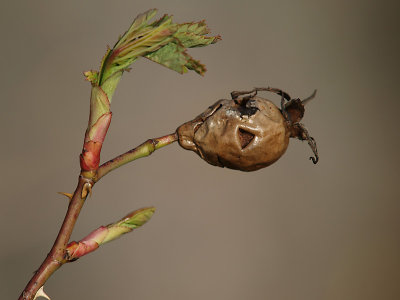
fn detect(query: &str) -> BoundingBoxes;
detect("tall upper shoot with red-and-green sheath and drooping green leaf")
[80,9,221,172]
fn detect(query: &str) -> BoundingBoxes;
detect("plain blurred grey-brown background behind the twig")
[0,0,400,300]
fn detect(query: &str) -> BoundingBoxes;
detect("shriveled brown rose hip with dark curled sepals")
[177,88,318,171]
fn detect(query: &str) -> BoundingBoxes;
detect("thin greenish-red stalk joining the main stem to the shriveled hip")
[93,132,178,182]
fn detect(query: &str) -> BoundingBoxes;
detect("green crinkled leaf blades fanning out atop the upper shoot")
[97,9,221,96]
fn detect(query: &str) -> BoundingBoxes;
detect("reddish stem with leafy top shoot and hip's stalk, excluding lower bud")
[19,10,220,300]
